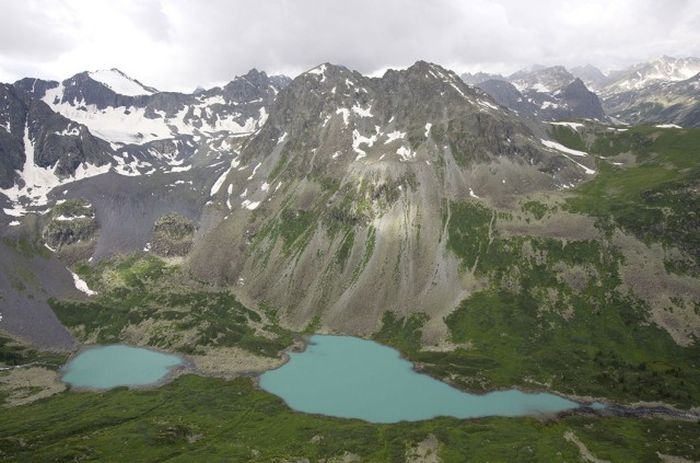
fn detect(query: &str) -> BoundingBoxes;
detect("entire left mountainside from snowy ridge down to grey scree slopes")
[0,70,288,347]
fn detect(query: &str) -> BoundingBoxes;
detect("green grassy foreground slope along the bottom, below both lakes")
[0,376,700,462]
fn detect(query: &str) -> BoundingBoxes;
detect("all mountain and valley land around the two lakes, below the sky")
[0,57,700,462]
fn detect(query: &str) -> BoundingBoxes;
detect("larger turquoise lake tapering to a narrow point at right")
[260,335,579,423]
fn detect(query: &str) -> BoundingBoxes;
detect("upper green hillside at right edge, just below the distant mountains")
[567,127,700,274]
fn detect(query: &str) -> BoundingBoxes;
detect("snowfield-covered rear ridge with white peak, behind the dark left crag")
[15,69,287,148]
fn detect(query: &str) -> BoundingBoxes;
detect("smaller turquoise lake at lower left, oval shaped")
[62,344,182,389]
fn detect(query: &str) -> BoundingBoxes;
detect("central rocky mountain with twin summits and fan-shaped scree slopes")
[191,62,592,333]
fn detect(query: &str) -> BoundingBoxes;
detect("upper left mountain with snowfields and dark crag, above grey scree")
[0,69,289,215]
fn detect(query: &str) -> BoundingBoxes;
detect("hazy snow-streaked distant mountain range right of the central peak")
[461,56,700,127]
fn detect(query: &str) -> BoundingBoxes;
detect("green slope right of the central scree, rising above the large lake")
[434,198,700,407]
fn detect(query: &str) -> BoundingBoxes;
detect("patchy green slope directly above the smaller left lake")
[49,256,292,357]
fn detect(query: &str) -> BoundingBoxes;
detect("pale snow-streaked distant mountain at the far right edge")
[600,56,700,127]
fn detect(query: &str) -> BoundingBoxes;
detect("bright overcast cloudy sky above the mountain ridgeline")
[0,0,700,91]
